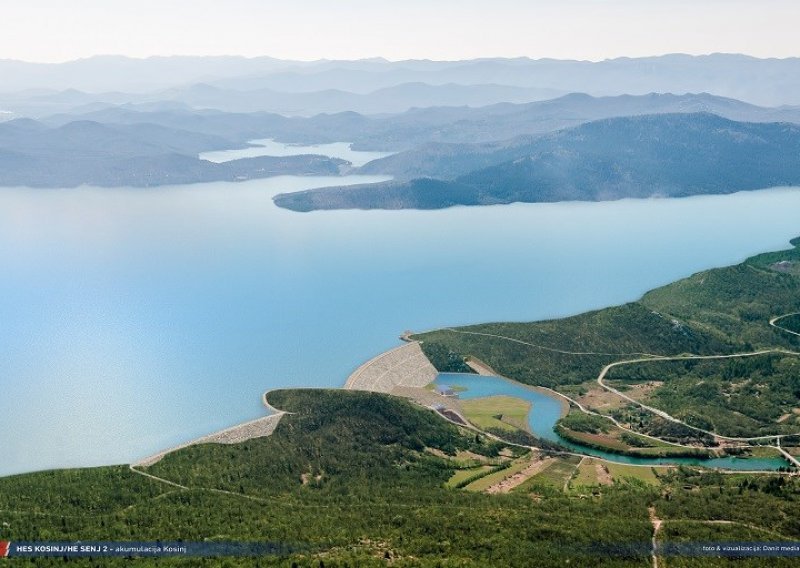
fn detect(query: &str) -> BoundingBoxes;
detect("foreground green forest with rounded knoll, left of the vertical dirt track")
[0,390,649,567]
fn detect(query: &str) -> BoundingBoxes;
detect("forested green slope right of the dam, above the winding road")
[414,240,800,404]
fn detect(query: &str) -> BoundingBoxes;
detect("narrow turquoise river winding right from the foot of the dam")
[436,373,788,471]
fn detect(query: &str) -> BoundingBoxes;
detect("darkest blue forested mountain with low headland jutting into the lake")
[275,113,800,211]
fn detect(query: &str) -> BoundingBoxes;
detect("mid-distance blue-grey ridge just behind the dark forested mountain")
[42,93,800,153]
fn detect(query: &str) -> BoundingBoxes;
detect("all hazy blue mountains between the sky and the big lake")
[0,54,800,200]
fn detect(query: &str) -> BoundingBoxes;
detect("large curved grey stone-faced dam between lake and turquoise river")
[344,341,439,393]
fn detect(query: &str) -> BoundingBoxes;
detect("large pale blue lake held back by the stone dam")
[0,162,800,474]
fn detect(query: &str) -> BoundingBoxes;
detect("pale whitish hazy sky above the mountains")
[0,0,800,62]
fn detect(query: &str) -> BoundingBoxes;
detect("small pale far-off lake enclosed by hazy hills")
[199,138,393,167]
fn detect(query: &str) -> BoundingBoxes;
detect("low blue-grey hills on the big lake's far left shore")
[0,119,347,187]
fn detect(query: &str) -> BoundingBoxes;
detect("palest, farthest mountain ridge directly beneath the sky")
[0,53,800,110]
